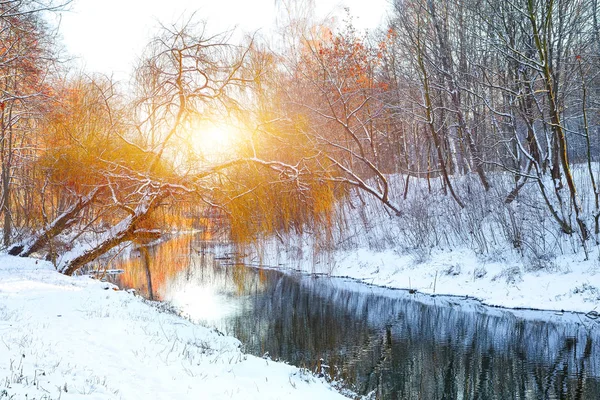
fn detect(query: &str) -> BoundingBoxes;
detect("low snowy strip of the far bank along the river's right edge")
[246,243,600,313]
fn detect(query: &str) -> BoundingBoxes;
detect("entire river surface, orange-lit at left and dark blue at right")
[106,236,600,400]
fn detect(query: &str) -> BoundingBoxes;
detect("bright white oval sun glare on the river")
[167,284,238,322]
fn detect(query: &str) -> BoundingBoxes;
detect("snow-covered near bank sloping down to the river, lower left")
[0,256,343,400]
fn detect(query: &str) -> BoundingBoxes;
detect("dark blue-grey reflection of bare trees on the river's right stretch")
[234,273,600,399]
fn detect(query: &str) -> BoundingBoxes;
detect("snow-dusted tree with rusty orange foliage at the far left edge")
[0,1,60,246]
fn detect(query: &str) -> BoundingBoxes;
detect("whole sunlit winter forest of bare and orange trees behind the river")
[0,0,600,275]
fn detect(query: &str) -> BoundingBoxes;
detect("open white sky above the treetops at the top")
[60,0,389,79]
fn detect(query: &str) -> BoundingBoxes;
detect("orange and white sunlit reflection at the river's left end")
[111,235,265,330]
